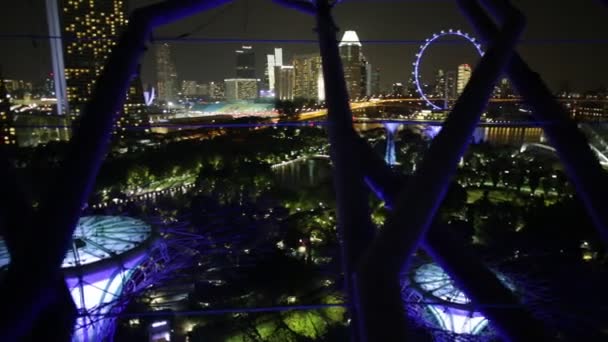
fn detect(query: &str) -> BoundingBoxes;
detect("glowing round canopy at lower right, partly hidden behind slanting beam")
[402,263,512,341]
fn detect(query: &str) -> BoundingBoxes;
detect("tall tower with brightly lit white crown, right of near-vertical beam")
[339,31,367,98]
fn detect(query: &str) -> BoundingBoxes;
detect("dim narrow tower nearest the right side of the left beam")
[156,43,178,102]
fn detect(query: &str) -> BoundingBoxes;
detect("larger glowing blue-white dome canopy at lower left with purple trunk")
[0,216,156,341]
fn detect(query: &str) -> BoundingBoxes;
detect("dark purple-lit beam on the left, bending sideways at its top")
[0,0,233,341]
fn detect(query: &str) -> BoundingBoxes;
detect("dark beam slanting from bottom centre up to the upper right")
[356,4,527,341]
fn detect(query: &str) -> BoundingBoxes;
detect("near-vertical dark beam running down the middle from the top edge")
[316,0,378,341]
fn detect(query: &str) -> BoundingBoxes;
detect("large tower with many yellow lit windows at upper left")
[55,0,127,114]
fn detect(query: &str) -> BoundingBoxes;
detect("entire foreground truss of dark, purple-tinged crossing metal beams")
[0,0,608,341]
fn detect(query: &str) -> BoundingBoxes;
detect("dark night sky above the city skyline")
[0,0,608,90]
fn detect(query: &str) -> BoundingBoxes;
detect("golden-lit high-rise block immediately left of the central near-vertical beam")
[293,54,325,100]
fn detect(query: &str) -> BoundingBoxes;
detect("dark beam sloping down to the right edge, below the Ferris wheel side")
[458,0,608,243]
